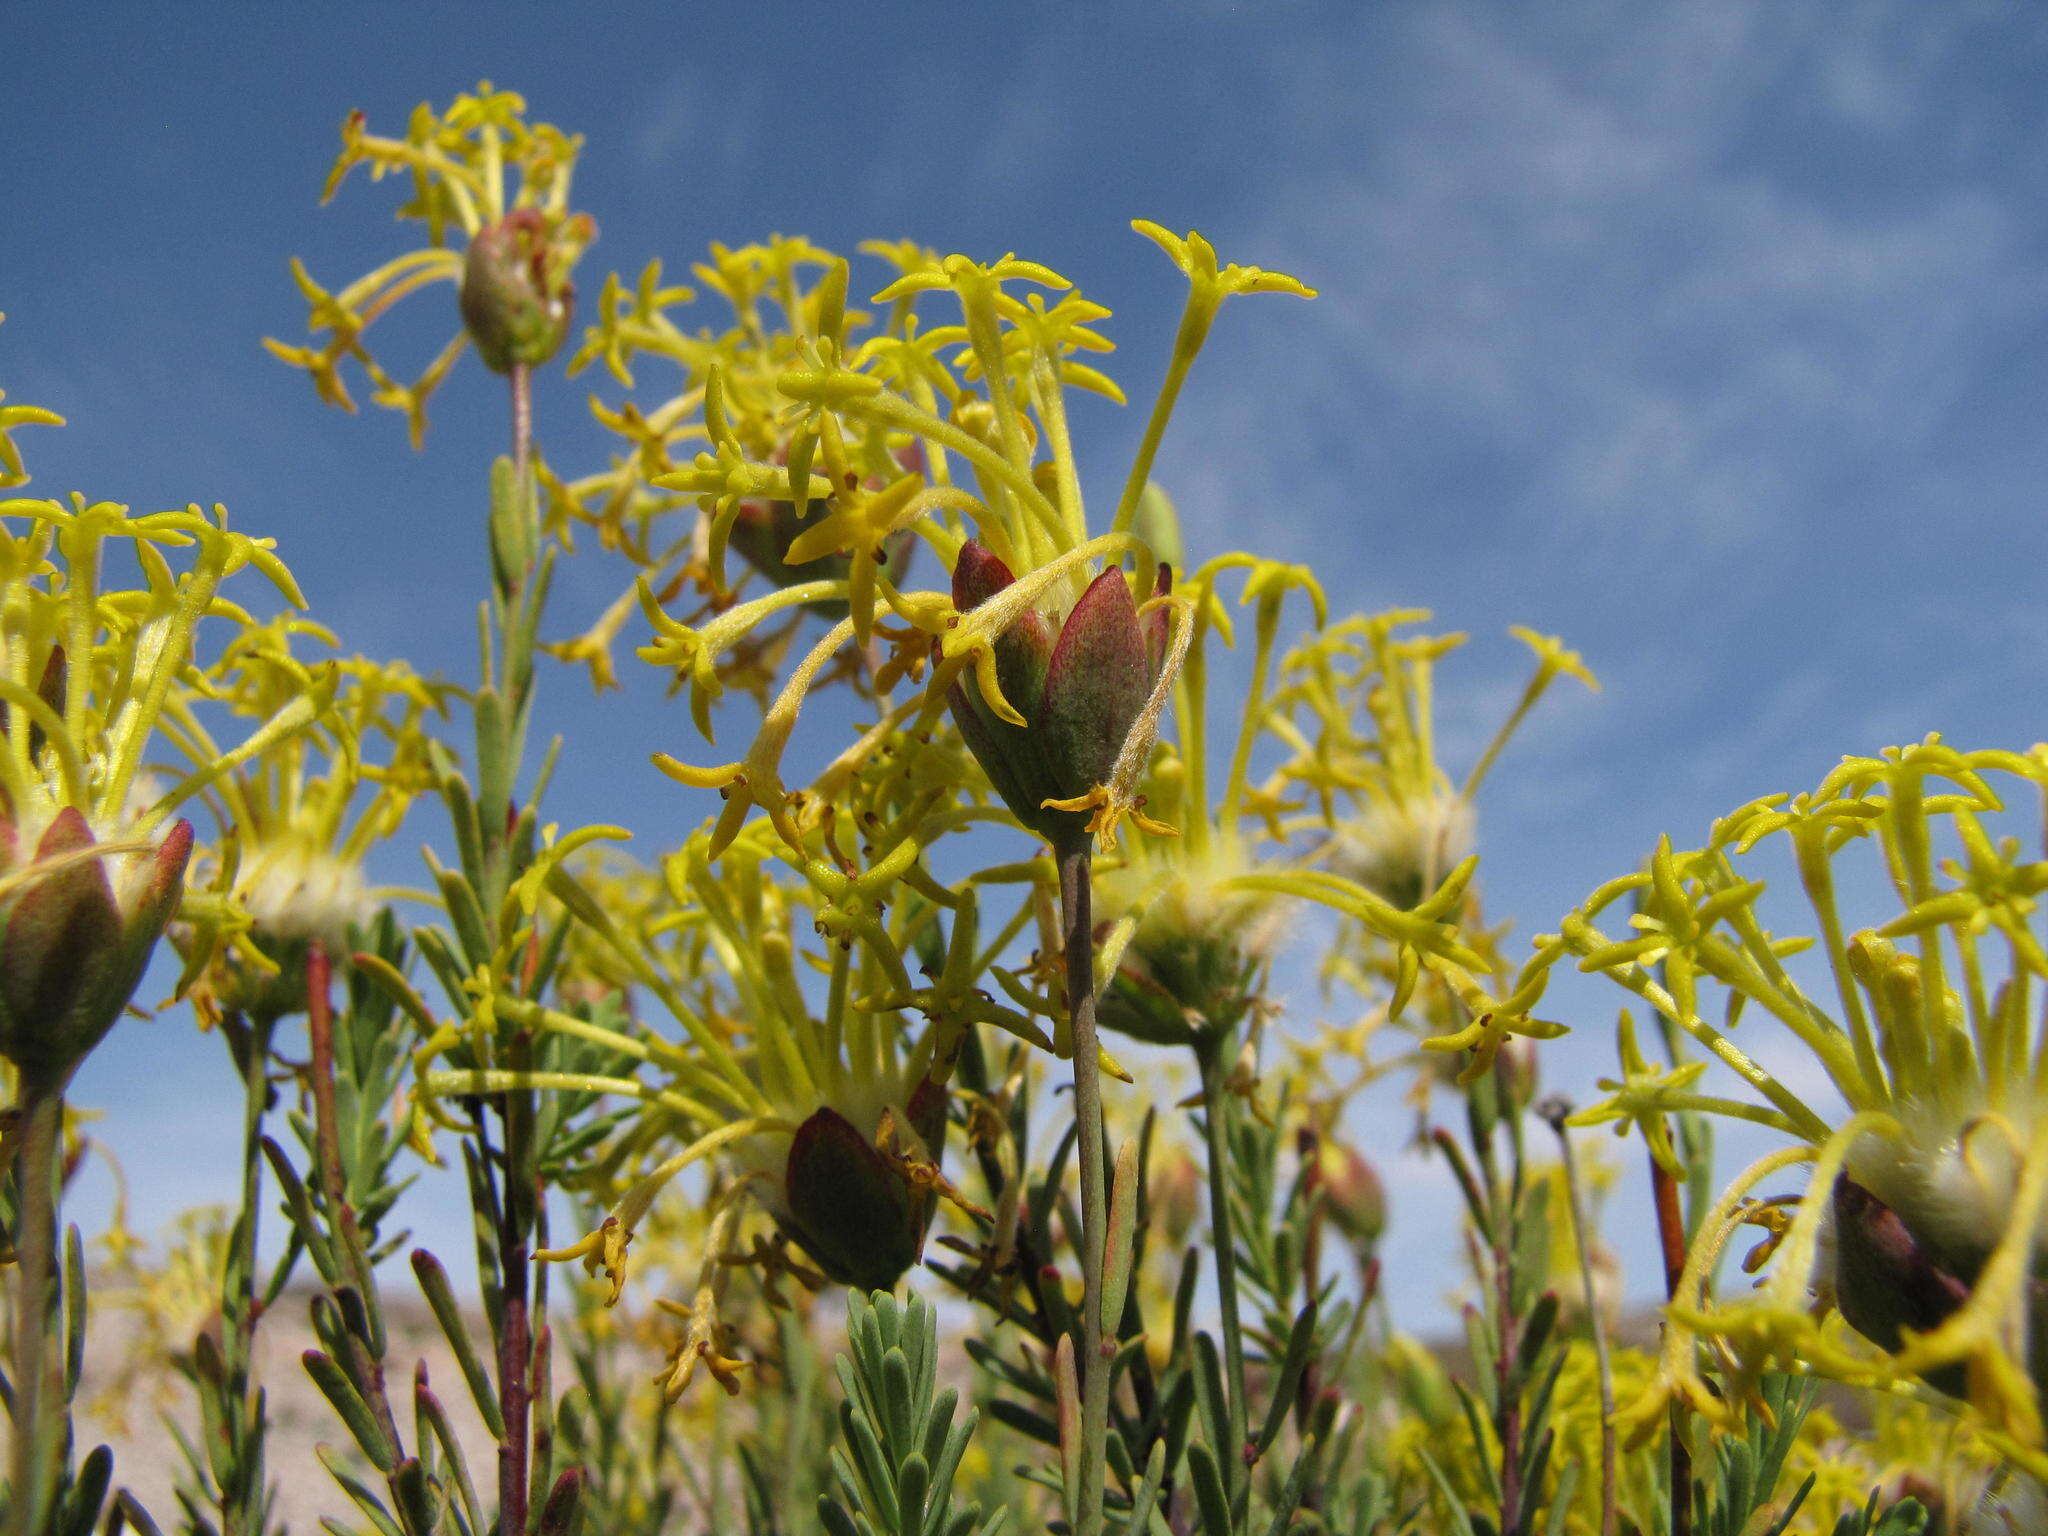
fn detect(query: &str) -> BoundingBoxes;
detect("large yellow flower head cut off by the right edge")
[1526,737,2048,1464]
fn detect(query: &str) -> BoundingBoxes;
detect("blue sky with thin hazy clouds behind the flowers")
[12,0,2048,1321]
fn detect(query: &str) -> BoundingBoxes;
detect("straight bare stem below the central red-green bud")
[1057,834,1110,1536]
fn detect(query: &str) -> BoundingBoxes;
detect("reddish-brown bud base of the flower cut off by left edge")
[0,807,193,1087]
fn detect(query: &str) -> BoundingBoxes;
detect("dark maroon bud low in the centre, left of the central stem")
[772,1081,946,1290]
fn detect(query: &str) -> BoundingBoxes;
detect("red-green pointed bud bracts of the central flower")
[950,541,1165,844]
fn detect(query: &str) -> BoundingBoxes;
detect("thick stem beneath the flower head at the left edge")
[10,1081,63,1536]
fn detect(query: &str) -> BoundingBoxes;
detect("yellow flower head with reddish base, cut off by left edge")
[0,496,334,1090]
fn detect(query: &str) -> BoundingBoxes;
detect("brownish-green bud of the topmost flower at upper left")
[461,209,594,373]
